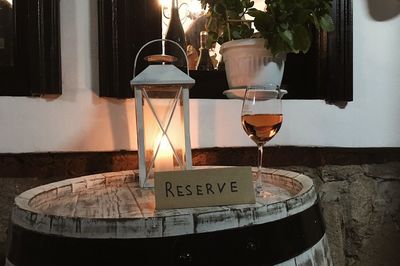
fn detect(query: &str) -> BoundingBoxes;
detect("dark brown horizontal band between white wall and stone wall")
[0,146,400,178]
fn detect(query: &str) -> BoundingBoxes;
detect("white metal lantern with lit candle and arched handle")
[131,39,195,187]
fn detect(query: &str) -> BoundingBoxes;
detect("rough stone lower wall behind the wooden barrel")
[0,149,400,266]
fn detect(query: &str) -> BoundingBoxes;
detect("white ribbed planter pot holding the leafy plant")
[220,39,286,89]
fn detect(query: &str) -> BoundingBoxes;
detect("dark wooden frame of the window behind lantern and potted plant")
[98,0,353,102]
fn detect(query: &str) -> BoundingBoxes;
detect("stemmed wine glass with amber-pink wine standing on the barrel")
[241,84,284,197]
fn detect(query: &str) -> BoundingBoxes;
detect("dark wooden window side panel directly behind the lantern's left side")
[98,0,161,98]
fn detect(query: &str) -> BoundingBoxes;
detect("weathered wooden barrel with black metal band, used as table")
[6,168,332,266]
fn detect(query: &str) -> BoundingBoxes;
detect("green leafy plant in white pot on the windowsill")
[200,0,334,92]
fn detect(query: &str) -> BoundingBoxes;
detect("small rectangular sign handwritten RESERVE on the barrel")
[154,167,255,209]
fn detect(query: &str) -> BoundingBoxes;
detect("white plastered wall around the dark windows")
[0,0,400,153]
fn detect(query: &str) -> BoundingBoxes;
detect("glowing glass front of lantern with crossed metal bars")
[141,85,186,179]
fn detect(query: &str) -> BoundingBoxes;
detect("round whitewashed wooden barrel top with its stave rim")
[11,168,317,238]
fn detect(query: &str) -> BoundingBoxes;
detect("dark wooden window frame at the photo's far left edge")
[0,0,62,96]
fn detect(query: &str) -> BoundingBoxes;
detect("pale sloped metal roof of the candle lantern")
[131,65,195,87]
